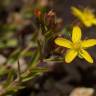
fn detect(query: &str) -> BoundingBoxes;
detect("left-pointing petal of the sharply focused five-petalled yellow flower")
[55,38,72,48]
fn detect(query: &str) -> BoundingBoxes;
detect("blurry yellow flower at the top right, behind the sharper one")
[71,7,96,27]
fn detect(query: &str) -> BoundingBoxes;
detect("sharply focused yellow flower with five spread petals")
[55,26,96,63]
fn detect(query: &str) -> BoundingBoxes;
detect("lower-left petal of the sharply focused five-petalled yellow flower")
[65,49,78,63]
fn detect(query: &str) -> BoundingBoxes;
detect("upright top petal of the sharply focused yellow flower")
[72,26,81,43]
